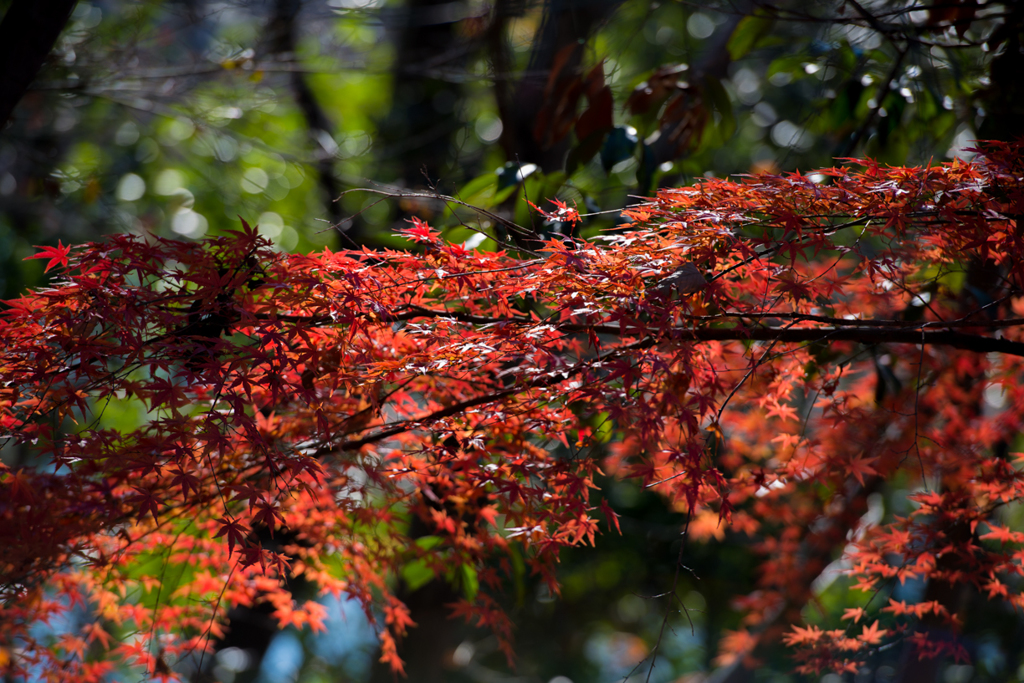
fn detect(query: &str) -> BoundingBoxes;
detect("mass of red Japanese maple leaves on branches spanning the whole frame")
[0,145,1024,680]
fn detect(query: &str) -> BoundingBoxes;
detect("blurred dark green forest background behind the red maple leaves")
[0,0,1024,683]
